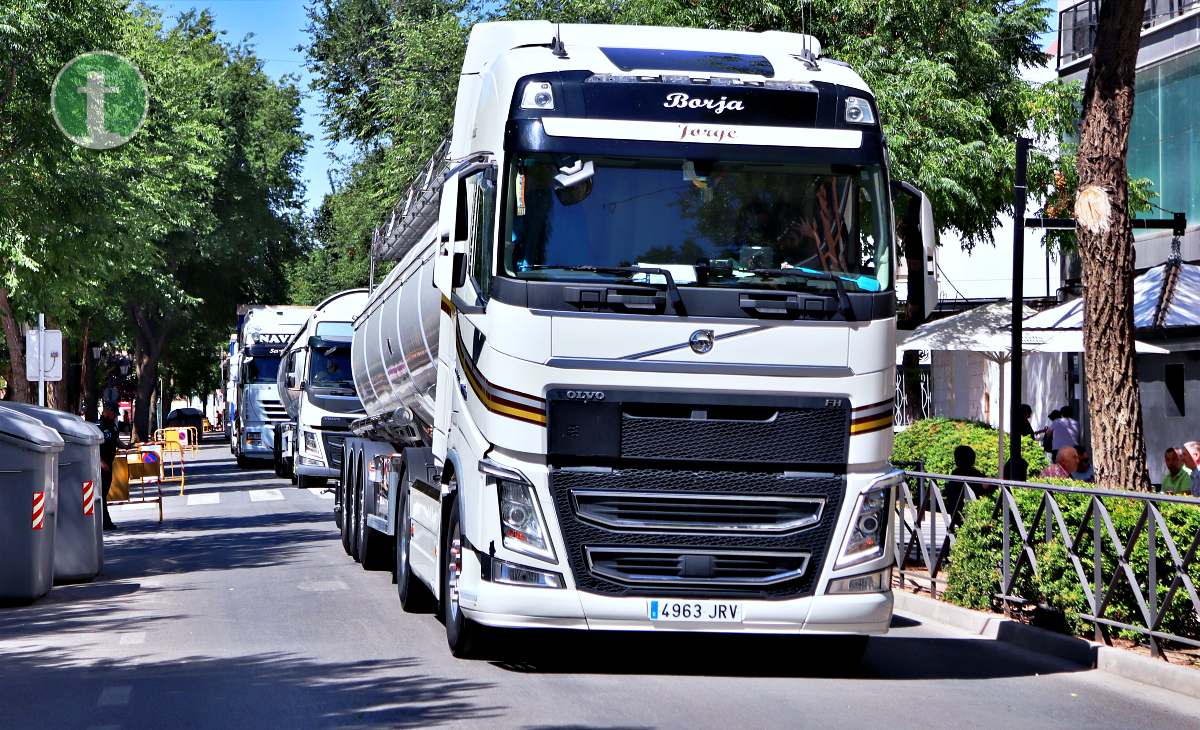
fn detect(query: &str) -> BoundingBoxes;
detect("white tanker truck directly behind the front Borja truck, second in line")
[274,289,367,489]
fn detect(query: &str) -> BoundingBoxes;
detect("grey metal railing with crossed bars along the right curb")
[894,465,1200,656]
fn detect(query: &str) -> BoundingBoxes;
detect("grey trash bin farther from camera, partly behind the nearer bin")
[4,403,104,581]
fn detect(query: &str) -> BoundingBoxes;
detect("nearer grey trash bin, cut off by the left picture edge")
[0,407,62,600]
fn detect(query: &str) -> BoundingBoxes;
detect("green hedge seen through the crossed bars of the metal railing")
[946,479,1200,641]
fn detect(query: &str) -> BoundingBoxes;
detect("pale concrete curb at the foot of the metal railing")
[892,591,1200,699]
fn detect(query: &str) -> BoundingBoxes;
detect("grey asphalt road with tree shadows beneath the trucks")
[0,443,1200,730]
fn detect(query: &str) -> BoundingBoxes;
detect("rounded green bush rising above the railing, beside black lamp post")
[892,418,1049,477]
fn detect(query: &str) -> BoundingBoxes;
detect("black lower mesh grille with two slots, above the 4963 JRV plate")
[550,467,845,599]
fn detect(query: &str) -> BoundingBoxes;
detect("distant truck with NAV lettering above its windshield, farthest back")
[229,304,312,468]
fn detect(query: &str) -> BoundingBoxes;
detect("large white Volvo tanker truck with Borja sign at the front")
[337,22,936,654]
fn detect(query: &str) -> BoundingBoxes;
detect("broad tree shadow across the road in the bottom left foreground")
[4,651,496,730]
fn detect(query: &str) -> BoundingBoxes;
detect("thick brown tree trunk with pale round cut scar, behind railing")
[1075,0,1150,490]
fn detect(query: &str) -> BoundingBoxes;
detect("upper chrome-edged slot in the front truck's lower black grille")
[571,489,824,533]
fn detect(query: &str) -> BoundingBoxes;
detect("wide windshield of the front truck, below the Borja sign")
[504,155,892,292]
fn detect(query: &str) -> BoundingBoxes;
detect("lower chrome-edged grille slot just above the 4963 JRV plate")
[586,548,809,587]
